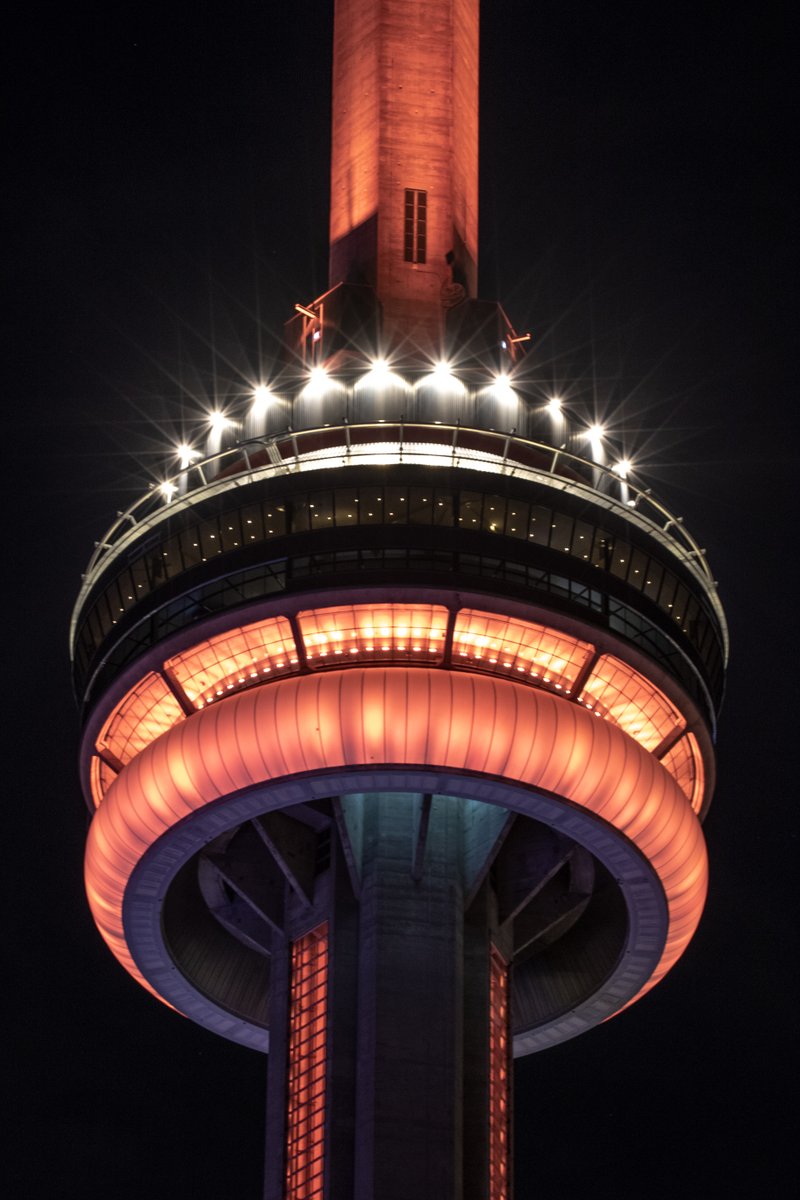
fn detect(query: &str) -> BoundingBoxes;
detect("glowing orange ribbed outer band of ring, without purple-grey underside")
[85,665,708,1022]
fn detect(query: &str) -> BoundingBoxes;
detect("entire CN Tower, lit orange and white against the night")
[71,0,728,1200]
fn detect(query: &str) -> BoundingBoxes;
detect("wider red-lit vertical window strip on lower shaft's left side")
[285,925,327,1200]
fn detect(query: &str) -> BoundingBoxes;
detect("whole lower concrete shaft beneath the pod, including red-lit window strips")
[265,792,513,1200]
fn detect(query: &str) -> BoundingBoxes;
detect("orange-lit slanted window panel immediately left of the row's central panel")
[164,617,297,708]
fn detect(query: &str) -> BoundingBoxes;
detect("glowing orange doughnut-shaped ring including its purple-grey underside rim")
[86,666,708,1052]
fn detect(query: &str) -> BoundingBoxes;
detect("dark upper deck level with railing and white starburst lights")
[71,364,728,726]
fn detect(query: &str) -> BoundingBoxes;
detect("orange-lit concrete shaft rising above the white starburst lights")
[330,0,479,354]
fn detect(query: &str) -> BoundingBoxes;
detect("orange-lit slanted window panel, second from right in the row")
[578,654,686,750]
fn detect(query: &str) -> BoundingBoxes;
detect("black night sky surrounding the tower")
[2,0,799,1200]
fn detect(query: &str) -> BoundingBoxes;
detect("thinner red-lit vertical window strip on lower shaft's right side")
[489,949,511,1200]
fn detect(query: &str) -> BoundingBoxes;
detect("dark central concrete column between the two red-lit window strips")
[353,794,463,1200]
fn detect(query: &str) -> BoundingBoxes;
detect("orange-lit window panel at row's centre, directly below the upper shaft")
[297,604,447,667]
